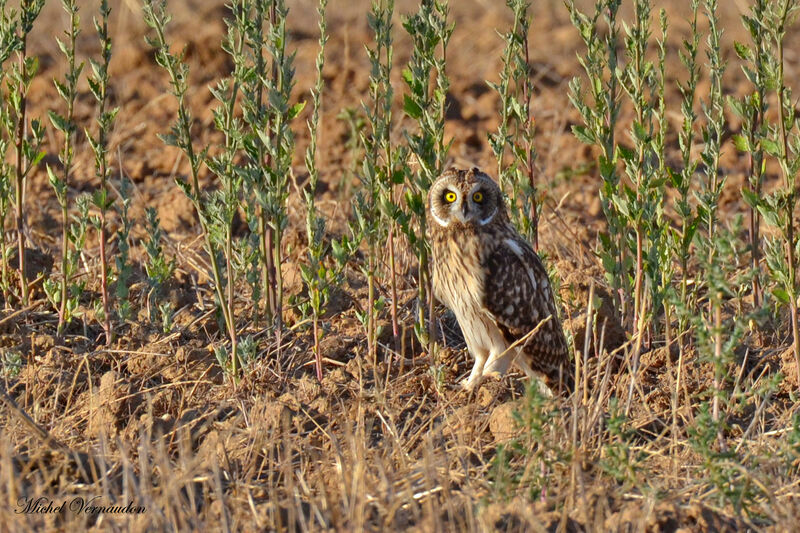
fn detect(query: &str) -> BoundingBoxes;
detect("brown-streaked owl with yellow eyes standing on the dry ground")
[427,168,573,391]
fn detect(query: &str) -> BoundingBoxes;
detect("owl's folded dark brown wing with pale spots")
[483,238,572,387]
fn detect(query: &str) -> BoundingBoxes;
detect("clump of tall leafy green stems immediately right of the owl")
[568,0,671,414]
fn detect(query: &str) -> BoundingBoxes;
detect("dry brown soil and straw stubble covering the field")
[0,0,800,531]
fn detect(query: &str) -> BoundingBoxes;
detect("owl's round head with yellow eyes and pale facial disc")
[428,168,506,228]
